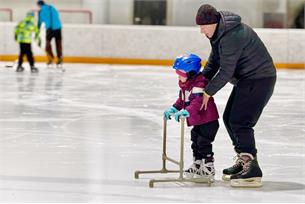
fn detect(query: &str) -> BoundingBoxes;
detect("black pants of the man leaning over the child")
[223,76,276,156]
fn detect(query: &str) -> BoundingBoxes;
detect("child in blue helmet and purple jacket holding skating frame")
[164,54,219,179]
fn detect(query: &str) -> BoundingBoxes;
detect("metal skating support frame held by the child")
[135,117,213,188]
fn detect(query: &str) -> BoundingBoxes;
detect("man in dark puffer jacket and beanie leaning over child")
[196,4,276,187]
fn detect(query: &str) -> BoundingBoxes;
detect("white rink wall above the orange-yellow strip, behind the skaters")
[0,23,305,63]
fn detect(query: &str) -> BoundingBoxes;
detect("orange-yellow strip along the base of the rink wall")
[0,55,305,69]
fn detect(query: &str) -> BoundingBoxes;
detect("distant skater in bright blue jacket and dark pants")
[37,0,63,65]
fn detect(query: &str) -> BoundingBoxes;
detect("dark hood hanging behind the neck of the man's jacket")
[212,11,241,41]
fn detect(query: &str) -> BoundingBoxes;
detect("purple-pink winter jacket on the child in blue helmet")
[173,73,219,126]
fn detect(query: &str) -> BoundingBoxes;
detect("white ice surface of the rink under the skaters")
[0,62,305,203]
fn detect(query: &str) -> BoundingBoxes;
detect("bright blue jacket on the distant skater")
[38,4,61,30]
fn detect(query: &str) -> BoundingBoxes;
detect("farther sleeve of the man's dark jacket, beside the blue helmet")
[202,45,219,80]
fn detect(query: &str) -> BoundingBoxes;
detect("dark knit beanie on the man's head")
[196,4,220,25]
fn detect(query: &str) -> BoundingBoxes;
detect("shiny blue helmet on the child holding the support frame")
[173,54,201,74]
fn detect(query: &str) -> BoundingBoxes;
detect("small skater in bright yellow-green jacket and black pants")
[15,11,41,73]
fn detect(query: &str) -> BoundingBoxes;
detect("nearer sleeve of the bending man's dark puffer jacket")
[205,33,242,96]
